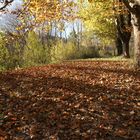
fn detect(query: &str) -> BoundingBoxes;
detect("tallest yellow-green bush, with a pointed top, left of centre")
[23,31,50,66]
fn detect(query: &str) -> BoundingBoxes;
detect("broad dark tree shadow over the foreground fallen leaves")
[0,67,140,140]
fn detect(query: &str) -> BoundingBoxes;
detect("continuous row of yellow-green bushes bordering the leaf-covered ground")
[0,31,100,70]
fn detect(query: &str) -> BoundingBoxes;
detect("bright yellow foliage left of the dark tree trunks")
[79,0,115,43]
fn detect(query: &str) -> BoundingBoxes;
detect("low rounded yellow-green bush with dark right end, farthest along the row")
[48,41,100,62]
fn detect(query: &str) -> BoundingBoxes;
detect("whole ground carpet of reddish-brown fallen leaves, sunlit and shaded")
[0,61,140,140]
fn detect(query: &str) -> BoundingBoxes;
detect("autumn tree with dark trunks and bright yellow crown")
[79,0,131,58]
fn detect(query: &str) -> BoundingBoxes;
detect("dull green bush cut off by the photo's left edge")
[0,35,23,70]
